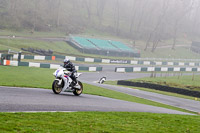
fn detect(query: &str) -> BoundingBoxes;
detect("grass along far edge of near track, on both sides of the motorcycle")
[0,66,195,112]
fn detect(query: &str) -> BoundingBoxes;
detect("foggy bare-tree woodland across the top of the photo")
[0,0,200,52]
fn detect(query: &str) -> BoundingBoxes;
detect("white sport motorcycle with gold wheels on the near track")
[52,67,83,96]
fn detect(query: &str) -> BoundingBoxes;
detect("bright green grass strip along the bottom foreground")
[0,112,200,133]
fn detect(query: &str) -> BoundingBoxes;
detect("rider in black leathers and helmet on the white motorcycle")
[63,59,77,86]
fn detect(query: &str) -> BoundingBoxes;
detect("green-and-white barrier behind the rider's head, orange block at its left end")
[3,60,102,72]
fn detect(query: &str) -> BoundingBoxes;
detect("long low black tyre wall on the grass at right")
[117,80,200,98]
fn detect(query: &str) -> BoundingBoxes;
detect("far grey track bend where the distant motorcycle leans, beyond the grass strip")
[80,72,200,112]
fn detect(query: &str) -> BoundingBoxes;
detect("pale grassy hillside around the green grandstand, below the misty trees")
[0,31,200,59]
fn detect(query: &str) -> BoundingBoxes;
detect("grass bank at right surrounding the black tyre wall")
[105,75,200,101]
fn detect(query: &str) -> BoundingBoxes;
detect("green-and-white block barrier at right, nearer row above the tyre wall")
[115,67,200,72]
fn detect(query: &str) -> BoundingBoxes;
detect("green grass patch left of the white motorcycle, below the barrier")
[0,66,55,88]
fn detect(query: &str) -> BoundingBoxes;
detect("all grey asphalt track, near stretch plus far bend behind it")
[0,72,200,114]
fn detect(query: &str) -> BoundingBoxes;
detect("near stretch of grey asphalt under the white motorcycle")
[0,87,192,114]
